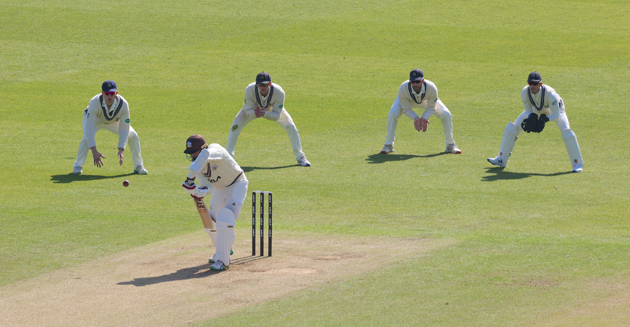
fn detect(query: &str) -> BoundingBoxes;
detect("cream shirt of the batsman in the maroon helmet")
[188,143,247,189]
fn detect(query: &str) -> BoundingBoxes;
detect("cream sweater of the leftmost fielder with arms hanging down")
[83,94,130,149]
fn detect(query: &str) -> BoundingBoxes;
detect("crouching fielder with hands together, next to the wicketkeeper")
[381,69,462,154]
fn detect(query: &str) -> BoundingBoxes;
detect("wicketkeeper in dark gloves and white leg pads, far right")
[488,72,584,173]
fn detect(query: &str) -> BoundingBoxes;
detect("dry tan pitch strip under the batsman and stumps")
[0,231,453,326]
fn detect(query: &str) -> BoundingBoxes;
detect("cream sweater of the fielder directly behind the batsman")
[241,83,284,121]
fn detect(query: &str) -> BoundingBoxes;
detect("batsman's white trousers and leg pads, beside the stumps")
[208,180,249,266]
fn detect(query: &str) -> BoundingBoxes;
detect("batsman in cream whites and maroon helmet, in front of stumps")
[182,135,249,270]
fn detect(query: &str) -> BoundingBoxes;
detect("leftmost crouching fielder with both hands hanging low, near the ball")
[72,81,149,175]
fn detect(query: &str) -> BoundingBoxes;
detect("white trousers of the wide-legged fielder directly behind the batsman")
[225,109,304,160]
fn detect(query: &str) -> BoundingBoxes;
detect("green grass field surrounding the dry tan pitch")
[0,0,630,326]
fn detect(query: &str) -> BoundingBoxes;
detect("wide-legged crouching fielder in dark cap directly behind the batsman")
[225,72,311,167]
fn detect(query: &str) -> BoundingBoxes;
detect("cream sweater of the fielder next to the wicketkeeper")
[398,79,439,119]
